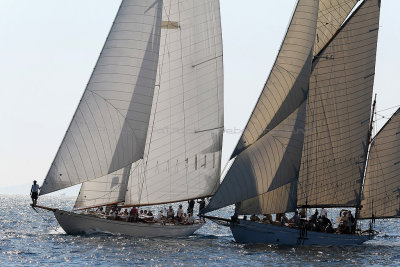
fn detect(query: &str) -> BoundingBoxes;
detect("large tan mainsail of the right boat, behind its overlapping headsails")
[298,0,380,207]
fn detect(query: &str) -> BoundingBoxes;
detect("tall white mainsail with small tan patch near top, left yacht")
[125,0,223,205]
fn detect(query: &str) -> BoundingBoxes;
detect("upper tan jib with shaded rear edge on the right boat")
[231,0,319,158]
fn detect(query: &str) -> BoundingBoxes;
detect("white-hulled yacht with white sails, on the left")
[35,0,223,237]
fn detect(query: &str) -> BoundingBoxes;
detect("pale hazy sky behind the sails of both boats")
[0,0,400,190]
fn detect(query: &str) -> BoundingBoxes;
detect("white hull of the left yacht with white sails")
[53,210,204,238]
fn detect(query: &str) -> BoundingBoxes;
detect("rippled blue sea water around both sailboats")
[0,195,400,266]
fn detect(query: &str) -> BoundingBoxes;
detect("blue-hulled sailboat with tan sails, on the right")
[205,0,400,245]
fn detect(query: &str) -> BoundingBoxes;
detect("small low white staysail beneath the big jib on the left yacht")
[74,166,131,209]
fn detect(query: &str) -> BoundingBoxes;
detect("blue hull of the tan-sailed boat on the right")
[230,220,374,246]
